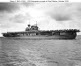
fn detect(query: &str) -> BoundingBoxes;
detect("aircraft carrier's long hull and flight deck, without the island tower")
[3,30,77,39]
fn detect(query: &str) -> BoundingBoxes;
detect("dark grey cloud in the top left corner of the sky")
[0,3,19,12]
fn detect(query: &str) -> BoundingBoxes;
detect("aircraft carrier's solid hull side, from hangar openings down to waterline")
[4,34,76,39]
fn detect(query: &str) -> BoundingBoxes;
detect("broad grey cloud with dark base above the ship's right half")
[46,3,80,21]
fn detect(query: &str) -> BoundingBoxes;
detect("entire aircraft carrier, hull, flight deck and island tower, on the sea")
[2,24,80,39]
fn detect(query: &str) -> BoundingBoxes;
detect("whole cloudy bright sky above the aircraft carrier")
[0,2,81,36]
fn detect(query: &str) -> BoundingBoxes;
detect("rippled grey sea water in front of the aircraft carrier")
[0,35,81,66]
